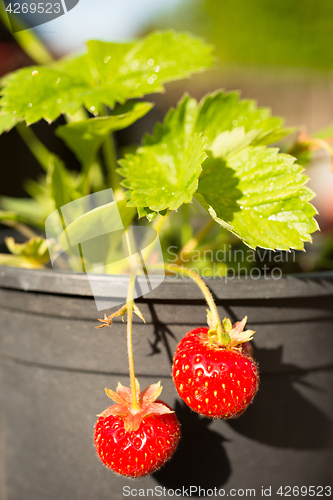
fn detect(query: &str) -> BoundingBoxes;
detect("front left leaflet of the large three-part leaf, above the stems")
[118,97,207,212]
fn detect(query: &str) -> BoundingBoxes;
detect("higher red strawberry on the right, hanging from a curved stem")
[172,318,259,419]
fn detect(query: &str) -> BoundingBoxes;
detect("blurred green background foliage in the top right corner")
[154,0,333,70]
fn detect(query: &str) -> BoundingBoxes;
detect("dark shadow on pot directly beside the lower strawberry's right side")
[154,401,231,490]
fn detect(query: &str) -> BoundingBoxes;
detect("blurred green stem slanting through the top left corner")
[0,1,53,64]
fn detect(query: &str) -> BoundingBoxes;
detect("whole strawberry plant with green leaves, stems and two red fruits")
[0,22,326,477]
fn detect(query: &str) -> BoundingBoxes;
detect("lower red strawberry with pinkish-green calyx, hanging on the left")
[94,382,180,477]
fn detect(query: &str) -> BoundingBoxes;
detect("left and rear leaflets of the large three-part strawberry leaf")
[118,91,289,220]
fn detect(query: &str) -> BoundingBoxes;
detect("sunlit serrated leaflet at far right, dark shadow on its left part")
[196,146,318,250]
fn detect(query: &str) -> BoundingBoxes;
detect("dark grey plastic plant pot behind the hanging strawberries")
[0,267,333,500]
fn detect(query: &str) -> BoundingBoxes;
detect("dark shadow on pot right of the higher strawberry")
[227,347,332,449]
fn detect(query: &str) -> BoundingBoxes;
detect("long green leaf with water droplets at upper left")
[1,31,212,123]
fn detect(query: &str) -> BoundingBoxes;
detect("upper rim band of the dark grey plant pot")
[0,266,333,301]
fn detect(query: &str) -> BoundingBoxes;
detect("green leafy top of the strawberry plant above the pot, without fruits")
[0,32,317,265]
